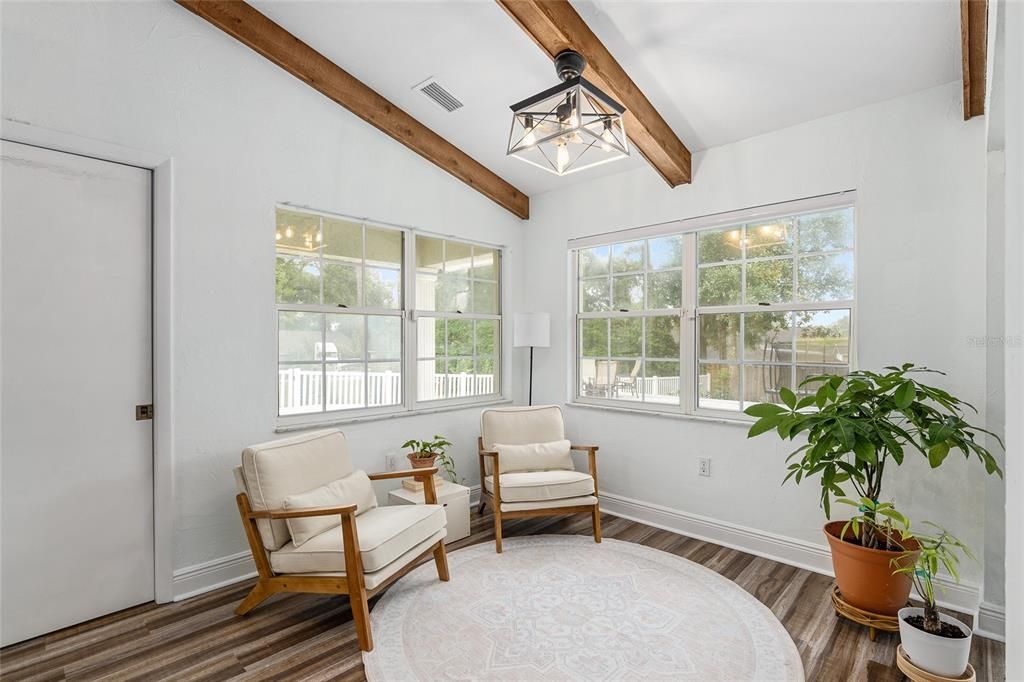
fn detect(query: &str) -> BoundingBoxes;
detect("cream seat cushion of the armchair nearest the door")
[270,505,446,573]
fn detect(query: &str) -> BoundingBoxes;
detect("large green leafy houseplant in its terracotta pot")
[744,363,1002,615]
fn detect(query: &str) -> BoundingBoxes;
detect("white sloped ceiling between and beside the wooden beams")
[245,0,961,195]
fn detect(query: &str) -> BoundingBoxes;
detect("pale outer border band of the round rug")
[362,535,805,682]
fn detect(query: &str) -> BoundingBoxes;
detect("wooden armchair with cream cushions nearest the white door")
[234,430,449,651]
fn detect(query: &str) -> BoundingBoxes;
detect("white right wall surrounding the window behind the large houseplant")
[524,83,986,587]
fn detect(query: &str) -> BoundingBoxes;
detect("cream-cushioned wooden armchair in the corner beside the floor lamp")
[477,406,601,553]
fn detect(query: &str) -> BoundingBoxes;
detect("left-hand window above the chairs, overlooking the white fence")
[274,208,501,417]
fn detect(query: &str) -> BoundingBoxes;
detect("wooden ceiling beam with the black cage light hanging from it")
[497,0,690,187]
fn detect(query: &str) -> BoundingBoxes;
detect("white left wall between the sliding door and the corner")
[2,2,522,588]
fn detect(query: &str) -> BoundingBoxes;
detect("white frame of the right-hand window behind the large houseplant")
[566,189,860,421]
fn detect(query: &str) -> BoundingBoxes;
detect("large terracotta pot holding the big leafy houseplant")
[824,521,918,615]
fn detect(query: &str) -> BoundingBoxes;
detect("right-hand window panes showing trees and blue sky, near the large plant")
[574,196,854,414]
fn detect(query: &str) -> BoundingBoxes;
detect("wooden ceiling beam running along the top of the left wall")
[177,0,529,220]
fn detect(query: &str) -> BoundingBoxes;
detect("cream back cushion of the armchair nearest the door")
[242,429,352,551]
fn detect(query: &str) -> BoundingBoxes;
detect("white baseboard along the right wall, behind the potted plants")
[601,493,987,610]
